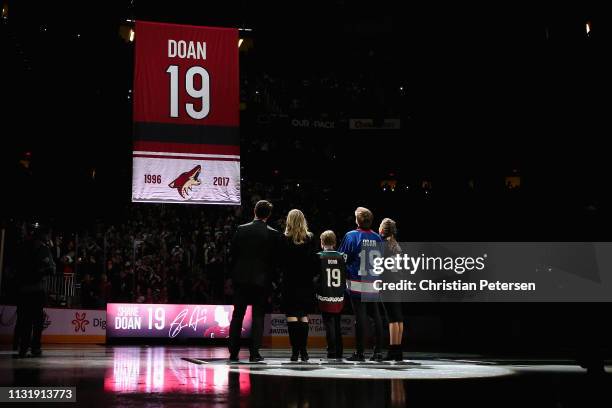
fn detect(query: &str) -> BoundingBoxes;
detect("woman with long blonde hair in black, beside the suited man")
[282,210,318,361]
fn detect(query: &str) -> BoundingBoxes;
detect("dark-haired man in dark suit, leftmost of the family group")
[229,200,281,362]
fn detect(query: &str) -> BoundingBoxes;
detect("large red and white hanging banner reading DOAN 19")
[132,21,240,204]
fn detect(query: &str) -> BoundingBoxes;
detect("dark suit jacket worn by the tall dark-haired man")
[232,220,282,288]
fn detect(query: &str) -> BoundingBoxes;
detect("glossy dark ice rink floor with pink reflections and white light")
[0,345,612,408]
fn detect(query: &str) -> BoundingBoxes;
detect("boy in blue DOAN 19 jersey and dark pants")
[338,207,383,361]
